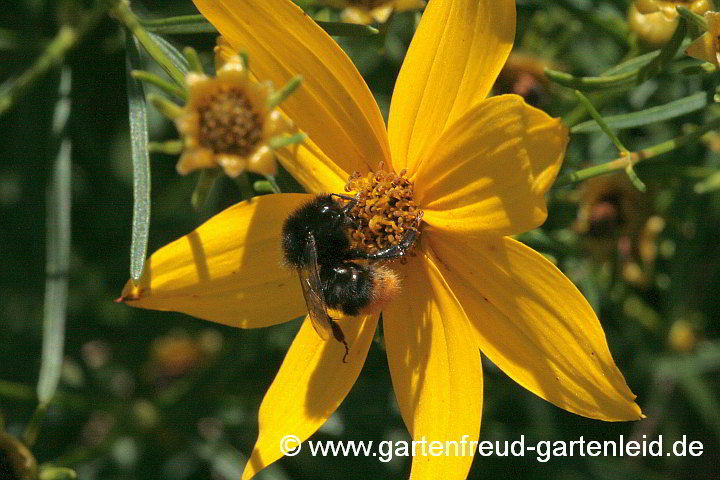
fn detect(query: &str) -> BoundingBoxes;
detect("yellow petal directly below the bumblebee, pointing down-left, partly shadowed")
[242,315,377,480]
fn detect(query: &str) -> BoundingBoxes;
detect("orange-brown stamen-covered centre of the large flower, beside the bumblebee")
[345,163,423,253]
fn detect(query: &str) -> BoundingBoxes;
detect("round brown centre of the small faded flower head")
[197,85,263,156]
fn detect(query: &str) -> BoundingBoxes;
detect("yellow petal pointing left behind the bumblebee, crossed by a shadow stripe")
[119,194,310,328]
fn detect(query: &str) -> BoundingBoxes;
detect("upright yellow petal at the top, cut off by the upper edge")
[388,0,515,174]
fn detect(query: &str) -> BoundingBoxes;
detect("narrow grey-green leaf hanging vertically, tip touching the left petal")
[126,35,150,280]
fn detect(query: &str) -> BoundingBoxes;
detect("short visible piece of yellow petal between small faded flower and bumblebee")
[275,138,348,193]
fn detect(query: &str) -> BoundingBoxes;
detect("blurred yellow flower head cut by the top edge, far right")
[628,0,711,47]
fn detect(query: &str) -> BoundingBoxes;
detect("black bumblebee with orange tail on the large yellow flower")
[282,194,417,362]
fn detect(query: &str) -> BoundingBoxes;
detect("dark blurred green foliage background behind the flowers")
[0,0,720,480]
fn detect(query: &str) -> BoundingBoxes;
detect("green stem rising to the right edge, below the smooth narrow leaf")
[553,117,720,188]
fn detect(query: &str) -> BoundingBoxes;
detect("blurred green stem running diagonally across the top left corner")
[0,1,113,115]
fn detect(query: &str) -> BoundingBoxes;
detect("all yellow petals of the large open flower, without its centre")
[121,0,642,479]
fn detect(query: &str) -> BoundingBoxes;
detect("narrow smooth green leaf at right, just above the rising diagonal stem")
[570,92,712,133]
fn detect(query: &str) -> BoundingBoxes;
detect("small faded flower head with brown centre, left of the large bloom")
[174,48,293,177]
